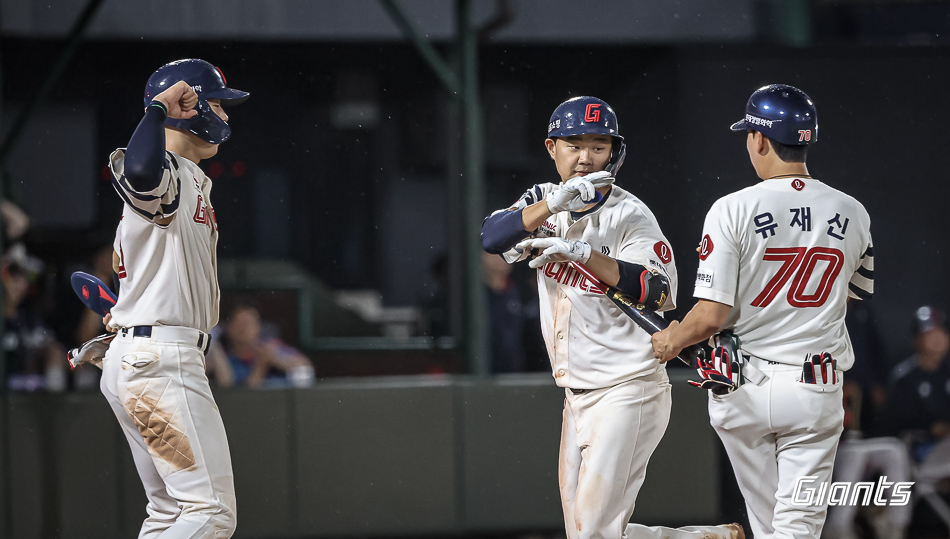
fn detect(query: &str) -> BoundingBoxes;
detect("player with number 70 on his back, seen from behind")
[653,84,874,538]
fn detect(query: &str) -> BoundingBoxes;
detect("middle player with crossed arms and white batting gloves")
[482,97,743,539]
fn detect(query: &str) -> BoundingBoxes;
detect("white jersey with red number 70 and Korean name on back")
[694,177,874,370]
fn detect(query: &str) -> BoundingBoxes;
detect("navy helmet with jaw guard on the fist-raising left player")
[145,58,251,144]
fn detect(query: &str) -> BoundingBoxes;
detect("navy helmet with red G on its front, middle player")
[548,95,627,177]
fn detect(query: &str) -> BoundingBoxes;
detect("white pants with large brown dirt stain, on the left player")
[100,328,237,539]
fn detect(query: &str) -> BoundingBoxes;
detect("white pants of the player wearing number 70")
[709,361,844,539]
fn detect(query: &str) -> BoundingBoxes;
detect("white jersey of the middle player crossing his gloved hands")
[505,183,677,389]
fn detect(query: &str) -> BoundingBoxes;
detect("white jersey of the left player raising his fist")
[109,149,220,332]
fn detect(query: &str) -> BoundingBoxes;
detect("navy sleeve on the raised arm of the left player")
[125,105,165,193]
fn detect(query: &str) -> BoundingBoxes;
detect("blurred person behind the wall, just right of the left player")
[214,306,314,387]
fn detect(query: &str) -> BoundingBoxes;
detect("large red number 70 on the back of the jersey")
[752,247,844,307]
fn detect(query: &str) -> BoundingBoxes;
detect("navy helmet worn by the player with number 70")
[731,84,818,146]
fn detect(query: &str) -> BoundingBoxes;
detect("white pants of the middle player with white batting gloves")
[558,369,730,539]
